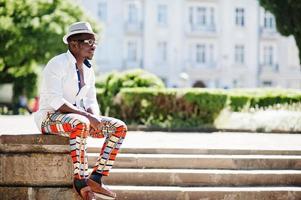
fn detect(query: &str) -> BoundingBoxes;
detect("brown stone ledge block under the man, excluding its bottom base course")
[0,134,73,191]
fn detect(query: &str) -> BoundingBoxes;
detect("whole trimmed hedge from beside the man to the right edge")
[98,88,301,128]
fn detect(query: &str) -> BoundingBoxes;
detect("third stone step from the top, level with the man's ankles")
[105,169,301,187]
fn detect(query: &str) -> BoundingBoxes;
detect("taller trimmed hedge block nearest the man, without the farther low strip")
[99,88,227,128]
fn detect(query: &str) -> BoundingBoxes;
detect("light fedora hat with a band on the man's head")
[63,22,96,44]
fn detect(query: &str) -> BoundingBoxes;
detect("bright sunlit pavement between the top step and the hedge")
[0,115,301,151]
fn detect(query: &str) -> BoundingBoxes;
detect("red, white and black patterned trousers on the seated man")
[42,113,127,179]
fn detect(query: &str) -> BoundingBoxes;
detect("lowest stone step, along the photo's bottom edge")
[106,186,301,200]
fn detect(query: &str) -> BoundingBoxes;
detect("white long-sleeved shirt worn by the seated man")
[34,51,99,129]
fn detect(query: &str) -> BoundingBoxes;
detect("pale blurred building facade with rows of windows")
[79,0,301,88]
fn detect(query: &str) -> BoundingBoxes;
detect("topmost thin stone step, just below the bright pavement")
[88,147,301,155]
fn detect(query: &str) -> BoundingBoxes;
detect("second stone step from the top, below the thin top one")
[88,153,301,169]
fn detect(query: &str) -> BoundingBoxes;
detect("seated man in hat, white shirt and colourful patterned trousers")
[35,22,127,200]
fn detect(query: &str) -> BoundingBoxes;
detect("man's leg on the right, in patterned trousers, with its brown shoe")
[87,117,127,198]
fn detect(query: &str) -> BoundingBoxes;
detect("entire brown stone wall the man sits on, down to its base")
[0,134,78,200]
